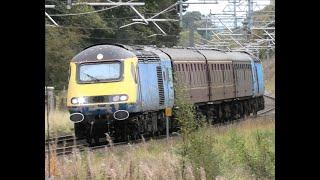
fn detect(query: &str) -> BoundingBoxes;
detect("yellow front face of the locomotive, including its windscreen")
[67,58,137,107]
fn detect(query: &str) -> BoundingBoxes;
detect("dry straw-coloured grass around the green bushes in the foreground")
[46,117,274,180]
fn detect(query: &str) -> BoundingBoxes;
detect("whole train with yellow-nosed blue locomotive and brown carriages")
[67,44,264,143]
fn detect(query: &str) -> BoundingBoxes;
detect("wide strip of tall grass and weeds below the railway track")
[46,117,274,180]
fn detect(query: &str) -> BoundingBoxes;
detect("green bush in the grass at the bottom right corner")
[227,130,275,179]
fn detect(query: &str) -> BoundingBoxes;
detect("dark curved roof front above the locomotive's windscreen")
[71,45,136,62]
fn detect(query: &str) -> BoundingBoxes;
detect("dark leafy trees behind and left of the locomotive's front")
[46,0,181,89]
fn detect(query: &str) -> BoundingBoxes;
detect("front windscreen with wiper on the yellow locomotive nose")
[78,61,122,83]
